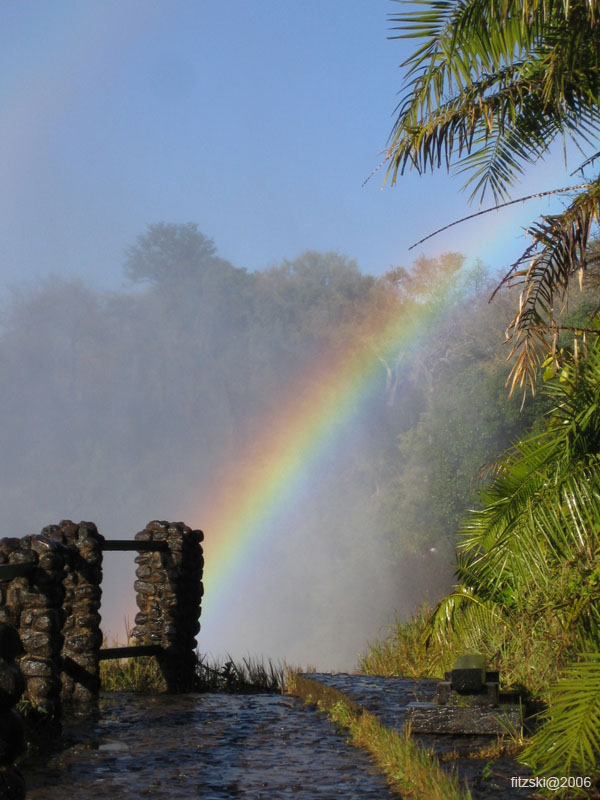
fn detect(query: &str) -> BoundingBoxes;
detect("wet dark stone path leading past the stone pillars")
[23,693,398,800]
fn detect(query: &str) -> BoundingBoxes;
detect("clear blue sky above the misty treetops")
[0,0,576,288]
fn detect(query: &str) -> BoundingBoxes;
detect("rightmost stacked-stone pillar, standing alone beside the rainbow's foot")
[132,520,204,691]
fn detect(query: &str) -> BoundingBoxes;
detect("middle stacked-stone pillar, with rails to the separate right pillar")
[42,519,104,713]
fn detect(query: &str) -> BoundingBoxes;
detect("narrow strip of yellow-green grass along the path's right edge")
[286,673,471,800]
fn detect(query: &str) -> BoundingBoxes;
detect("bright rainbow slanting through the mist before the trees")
[189,262,466,619]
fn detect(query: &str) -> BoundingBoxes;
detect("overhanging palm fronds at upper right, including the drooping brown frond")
[386,0,600,392]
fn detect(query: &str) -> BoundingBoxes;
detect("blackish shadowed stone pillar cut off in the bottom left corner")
[0,620,25,800]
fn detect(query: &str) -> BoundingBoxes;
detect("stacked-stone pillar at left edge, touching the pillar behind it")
[0,536,67,726]
